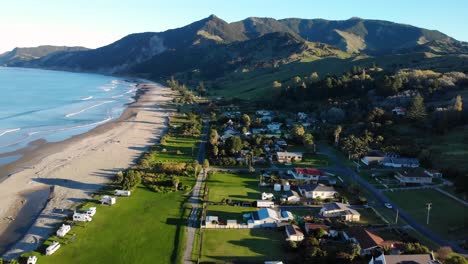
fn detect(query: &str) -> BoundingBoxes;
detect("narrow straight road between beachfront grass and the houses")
[184,119,208,264]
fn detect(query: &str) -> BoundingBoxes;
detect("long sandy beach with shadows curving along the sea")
[0,83,175,259]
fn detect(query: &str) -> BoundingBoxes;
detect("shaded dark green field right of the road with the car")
[385,190,468,239]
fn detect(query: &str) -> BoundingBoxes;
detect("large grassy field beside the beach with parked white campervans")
[33,180,193,264]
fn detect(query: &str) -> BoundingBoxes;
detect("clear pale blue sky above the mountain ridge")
[0,0,468,53]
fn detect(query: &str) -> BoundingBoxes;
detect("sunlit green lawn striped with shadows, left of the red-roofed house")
[207,172,261,202]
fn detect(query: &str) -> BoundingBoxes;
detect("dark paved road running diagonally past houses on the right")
[319,143,468,254]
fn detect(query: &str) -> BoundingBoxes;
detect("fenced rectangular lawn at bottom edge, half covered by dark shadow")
[201,229,286,263]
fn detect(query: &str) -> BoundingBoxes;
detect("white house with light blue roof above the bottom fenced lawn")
[247,208,294,228]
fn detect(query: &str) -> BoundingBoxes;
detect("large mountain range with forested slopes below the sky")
[7,15,468,78]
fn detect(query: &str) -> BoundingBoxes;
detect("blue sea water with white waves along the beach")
[0,67,136,160]
